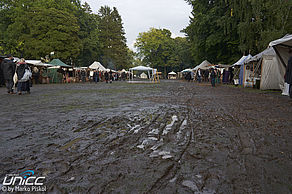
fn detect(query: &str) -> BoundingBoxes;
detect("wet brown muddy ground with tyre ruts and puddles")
[0,81,292,193]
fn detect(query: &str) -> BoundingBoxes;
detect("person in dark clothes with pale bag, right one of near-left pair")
[16,59,32,95]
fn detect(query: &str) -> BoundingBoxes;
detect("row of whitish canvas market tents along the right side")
[182,34,292,93]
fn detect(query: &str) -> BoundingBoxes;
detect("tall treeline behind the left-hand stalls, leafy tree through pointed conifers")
[0,0,131,68]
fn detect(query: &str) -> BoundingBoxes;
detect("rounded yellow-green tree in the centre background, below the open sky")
[134,28,192,76]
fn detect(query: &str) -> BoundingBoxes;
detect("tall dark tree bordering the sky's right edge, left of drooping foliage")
[184,0,240,64]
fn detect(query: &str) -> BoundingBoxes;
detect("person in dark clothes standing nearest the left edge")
[2,54,16,94]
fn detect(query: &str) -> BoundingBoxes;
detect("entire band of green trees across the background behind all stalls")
[0,0,292,72]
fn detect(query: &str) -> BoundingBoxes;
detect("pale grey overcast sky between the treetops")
[82,0,191,49]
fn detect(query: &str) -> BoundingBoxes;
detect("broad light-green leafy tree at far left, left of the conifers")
[0,0,80,60]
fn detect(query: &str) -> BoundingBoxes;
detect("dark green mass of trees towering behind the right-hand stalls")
[184,0,292,64]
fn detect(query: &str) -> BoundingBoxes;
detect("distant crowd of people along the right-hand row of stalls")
[184,68,234,87]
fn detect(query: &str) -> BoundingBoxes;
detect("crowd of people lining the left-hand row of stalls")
[0,54,130,95]
